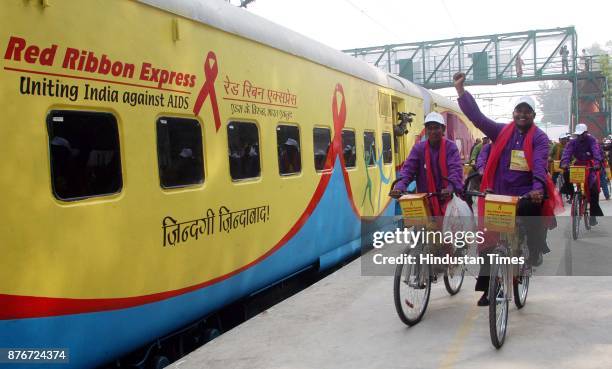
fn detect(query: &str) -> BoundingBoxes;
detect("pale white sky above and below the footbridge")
[231,0,612,128]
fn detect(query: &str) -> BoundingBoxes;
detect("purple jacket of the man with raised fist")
[458,91,548,196]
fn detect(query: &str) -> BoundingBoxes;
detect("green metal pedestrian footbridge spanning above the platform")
[343,27,610,136]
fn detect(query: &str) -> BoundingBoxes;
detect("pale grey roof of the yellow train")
[138,0,423,98]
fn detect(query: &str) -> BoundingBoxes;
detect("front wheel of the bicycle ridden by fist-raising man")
[489,247,509,349]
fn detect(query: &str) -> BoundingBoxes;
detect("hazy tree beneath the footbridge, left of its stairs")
[537,81,572,124]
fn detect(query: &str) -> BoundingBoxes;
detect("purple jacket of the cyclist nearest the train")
[394,138,463,193]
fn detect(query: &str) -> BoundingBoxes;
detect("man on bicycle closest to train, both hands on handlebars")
[389,112,463,216]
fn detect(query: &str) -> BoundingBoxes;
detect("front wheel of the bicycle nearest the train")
[393,247,431,326]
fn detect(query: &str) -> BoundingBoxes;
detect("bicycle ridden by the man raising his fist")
[466,191,533,349]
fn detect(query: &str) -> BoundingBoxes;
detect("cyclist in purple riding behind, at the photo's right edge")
[560,123,603,225]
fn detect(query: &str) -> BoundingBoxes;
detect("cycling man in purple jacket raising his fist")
[453,72,563,306]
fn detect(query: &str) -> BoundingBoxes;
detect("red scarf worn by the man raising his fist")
[478,121,563,217]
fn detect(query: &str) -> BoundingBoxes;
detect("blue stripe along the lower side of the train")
[0,161,393,369]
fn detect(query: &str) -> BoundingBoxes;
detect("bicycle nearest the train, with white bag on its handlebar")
[391,178,465,326]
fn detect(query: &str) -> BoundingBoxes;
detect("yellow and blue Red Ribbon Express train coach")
[0,0,477,368]
